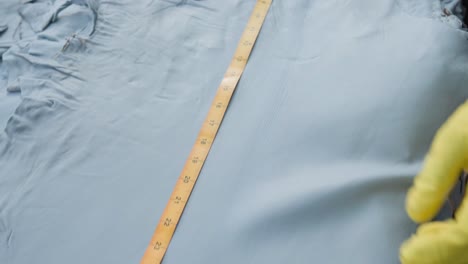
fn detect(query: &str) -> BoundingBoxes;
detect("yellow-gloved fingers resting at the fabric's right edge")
[400,102,468,264]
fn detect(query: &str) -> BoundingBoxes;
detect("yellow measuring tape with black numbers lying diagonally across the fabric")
[141,0,272,264]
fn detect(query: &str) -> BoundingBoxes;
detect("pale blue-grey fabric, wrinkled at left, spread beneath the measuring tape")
[0,0,468,264]
